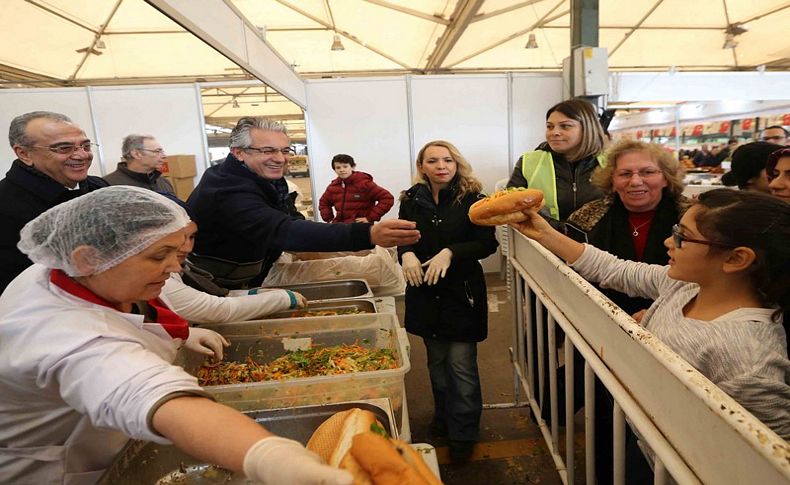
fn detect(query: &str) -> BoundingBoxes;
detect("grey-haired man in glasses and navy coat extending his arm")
[187,117,419,289]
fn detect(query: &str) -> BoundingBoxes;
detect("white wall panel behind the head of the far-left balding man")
[0,88,101,177]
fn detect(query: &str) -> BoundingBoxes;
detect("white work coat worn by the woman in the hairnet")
[0,264,210,485]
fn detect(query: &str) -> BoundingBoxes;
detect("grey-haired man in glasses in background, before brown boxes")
[104,135,175,194]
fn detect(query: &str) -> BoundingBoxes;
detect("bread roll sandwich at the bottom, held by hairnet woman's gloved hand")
[307,408,441,485]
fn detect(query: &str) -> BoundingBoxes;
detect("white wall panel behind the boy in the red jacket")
[306,77,413,220]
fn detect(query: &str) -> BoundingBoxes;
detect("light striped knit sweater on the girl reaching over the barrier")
[572,245,790,440]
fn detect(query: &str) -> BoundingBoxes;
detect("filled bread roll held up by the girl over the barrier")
[469,187,543,226]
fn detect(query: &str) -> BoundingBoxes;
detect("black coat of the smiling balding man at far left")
[0,159,107,292]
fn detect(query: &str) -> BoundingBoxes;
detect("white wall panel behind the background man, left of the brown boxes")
[92,84,206,182]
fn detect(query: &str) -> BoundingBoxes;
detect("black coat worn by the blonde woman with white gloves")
[398,180,498,342]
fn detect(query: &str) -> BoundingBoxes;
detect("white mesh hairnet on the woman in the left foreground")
[17,186,189,276]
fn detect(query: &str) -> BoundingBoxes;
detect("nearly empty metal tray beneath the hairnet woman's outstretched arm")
[97,399,397,485]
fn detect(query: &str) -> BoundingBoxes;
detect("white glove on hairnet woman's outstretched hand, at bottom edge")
[244,436,353,485]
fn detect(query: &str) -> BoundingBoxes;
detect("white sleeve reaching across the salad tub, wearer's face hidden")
[159,273,296,323]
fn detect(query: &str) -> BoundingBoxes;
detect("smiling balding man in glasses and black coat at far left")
[0,111,107,292]
